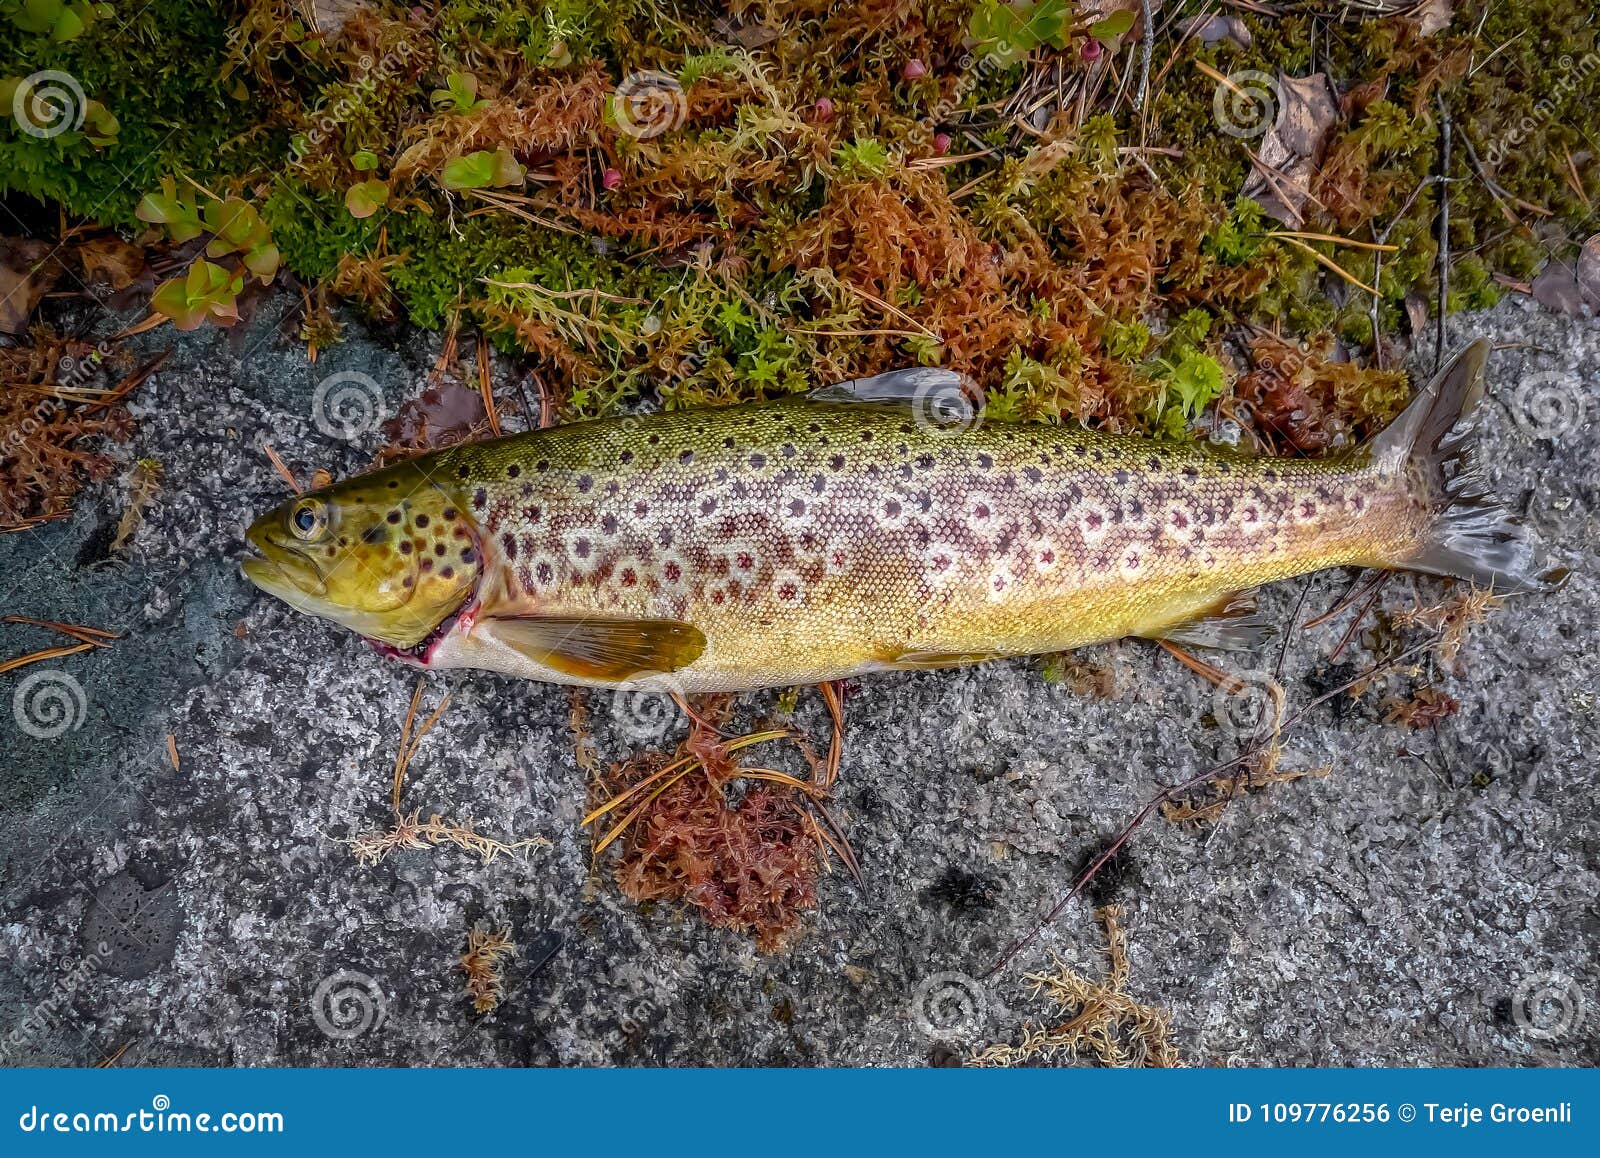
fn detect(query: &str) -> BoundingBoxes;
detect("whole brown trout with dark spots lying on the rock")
[245,342,1562,691]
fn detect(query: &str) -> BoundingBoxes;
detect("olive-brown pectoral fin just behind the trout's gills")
[474,616,706,681]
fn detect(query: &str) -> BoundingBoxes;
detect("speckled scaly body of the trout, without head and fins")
[416,401,1427,691]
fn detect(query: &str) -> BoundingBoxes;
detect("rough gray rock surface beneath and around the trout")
[0,294,1600,1065]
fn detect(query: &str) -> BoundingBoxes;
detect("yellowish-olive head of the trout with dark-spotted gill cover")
[243,462,483,649]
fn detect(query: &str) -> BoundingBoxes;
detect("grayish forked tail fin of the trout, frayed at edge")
[1370,337,1566,593]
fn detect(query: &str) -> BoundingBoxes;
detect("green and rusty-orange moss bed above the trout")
[0,0,1600,433]
